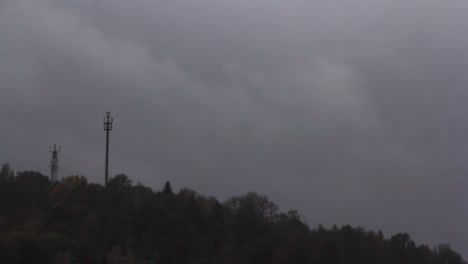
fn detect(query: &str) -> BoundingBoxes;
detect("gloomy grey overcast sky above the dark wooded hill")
[0,0,468,257]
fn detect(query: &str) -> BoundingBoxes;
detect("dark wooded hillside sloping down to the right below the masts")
[0,165,465,264]
